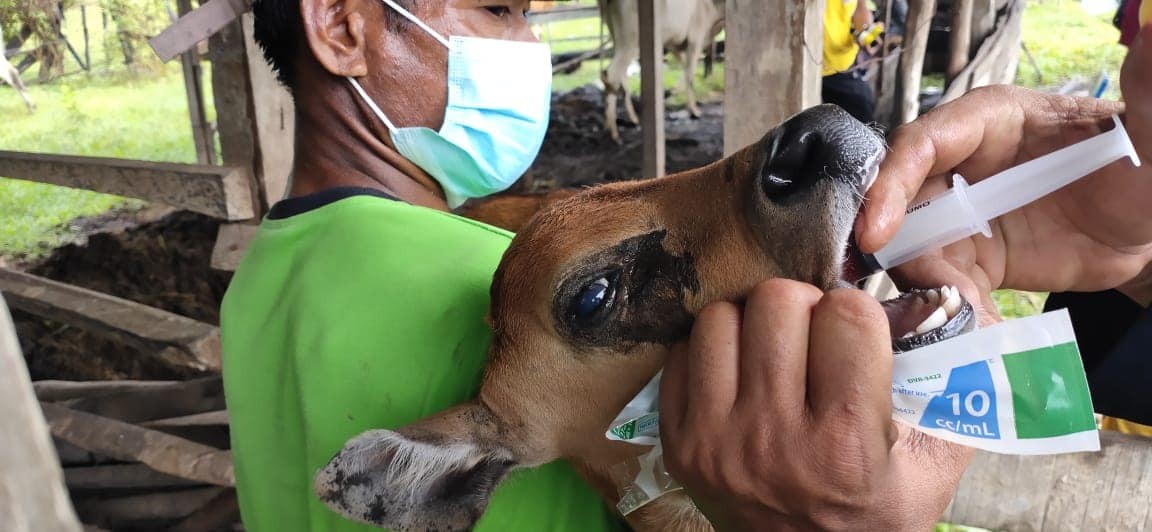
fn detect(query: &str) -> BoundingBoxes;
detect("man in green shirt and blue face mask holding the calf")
[221,0,620,532]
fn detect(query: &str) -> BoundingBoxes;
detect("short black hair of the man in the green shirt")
[252,0,414,92]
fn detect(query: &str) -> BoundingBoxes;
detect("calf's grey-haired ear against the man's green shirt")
[313,404,517,531]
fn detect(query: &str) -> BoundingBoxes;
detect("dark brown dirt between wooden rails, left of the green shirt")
[14,212,230,380]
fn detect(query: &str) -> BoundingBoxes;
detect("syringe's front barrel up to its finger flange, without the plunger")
[872,175,990,269]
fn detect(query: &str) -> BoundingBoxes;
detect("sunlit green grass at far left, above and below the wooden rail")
[0,64,209,258]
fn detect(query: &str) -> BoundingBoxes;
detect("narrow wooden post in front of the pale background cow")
[639,0,665,177]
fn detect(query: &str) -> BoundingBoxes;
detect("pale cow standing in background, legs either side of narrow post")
[597,0,725,142]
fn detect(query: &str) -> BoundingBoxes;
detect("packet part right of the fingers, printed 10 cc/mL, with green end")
[892,311,1100,455]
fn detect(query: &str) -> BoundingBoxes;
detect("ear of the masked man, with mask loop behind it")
[298,0,367,77]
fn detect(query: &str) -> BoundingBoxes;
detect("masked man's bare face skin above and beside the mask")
[361,0,537,133]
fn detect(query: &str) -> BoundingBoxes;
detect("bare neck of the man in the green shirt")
[289,89,448,211]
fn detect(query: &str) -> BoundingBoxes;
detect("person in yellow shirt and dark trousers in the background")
[820,0,876,123]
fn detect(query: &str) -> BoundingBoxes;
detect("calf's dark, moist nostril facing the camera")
[760,131,826,199]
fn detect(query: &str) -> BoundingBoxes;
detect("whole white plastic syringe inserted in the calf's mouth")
[865,116,1140,271]
